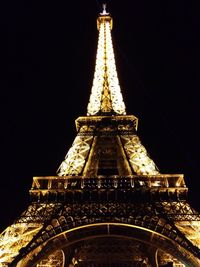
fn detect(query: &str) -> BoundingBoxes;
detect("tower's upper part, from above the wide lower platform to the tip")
[58,4,158,176]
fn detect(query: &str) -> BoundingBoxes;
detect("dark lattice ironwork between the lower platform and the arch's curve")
[8,203,200,266]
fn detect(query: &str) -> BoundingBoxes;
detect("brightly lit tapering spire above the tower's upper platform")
[87,4,126,115]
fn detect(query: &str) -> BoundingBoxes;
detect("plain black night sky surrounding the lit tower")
[0,0,200,230]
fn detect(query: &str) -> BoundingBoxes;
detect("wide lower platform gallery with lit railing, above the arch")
[30,174,188,203]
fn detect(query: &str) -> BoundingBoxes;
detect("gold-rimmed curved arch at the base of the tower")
[17,222,199,267]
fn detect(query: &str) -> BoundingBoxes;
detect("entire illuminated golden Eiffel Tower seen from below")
[0,5,200,267]
